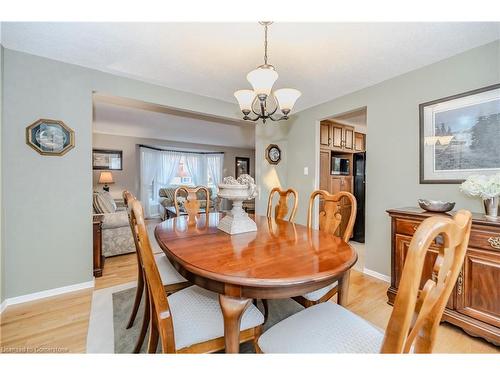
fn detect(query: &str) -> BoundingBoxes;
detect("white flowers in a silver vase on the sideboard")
[460,173,500,219]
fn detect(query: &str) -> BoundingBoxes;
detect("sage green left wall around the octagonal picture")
[2,49,239,298]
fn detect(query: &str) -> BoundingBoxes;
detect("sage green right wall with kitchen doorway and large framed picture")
[264,41,500,275]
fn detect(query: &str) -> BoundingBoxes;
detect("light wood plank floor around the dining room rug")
[0,254,500,353]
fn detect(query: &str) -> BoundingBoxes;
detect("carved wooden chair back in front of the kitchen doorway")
[307,190,357,242]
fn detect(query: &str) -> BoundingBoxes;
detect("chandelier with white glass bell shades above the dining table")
[234,22,302,123]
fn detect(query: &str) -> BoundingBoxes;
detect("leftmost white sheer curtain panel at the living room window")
[139,147,160,217]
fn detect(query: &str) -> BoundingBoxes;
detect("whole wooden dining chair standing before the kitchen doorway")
[294,190,357,307]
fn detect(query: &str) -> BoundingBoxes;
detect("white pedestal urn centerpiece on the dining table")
[217,174,257,234]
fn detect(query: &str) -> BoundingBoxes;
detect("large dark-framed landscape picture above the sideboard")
[419,84,500,184]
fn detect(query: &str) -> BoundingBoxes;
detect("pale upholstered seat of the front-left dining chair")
[168,285,264,350]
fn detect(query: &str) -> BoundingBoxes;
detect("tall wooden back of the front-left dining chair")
[129,200,175,353]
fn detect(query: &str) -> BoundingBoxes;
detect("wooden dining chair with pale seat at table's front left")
[130,200,264,353]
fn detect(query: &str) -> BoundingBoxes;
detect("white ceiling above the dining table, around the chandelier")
[2,22,500,110]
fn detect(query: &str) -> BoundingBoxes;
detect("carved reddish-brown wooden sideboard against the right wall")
[387,207,500,345]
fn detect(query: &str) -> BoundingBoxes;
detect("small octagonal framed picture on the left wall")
[26,119,75,156]
